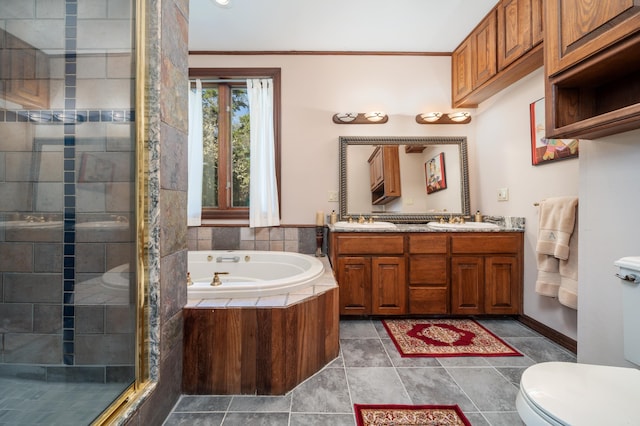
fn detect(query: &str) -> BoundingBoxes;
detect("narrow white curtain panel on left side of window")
[187,79,203,226]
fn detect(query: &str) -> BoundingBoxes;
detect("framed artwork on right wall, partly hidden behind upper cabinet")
[529,98,580,166]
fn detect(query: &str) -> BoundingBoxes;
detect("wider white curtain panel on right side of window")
[247,79,280,228]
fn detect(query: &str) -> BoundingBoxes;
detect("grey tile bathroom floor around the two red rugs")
[164,319,576,426]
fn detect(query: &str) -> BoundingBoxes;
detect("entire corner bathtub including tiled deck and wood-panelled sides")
[182,250,340,395]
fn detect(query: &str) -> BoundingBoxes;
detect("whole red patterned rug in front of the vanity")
[382,319,522,357]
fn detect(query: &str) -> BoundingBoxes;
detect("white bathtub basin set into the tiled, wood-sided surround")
[187,250,324,299]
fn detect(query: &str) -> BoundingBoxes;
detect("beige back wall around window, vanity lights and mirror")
[189,55,474,225]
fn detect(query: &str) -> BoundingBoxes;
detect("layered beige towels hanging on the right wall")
[536,197,578,309]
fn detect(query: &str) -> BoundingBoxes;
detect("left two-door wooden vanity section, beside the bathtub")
[330,233,407,315]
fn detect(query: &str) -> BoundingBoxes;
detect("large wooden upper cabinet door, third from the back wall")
[497,0,532,71]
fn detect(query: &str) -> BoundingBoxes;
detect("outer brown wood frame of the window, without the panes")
[189,68,282,220]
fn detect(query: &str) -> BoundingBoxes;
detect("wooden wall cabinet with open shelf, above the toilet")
[544,0,640,139]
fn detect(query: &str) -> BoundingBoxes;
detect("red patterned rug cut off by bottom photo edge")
[353,404,471,426]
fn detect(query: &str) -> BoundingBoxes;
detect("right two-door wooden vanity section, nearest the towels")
[451,233,523,315]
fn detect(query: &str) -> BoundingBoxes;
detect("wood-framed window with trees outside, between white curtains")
[189,68,280,219]
